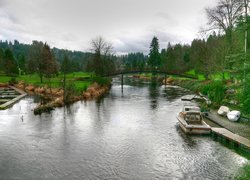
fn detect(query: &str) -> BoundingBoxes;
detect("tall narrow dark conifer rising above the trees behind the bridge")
[148,37,161,68]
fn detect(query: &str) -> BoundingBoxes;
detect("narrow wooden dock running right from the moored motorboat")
[211,128,250,152]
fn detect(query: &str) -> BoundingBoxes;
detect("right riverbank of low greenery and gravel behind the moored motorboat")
[163,78,250,140]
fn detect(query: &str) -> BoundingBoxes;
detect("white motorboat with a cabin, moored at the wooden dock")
[177,106,211,134]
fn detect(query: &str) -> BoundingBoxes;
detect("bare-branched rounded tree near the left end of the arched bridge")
[88,37,114,75]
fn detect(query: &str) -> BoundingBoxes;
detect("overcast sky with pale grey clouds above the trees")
[0,0,216,53]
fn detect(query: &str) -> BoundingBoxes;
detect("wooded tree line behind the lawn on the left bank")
[0,40,93,75]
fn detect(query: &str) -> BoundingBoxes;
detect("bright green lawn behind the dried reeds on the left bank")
[0,72,92,91]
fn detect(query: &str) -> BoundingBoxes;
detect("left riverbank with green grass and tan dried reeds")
[0,72,110,114]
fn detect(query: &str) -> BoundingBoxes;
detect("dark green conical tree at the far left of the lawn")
[3,49,18,75]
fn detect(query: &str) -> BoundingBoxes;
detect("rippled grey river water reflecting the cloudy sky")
[0,78,249,180]
